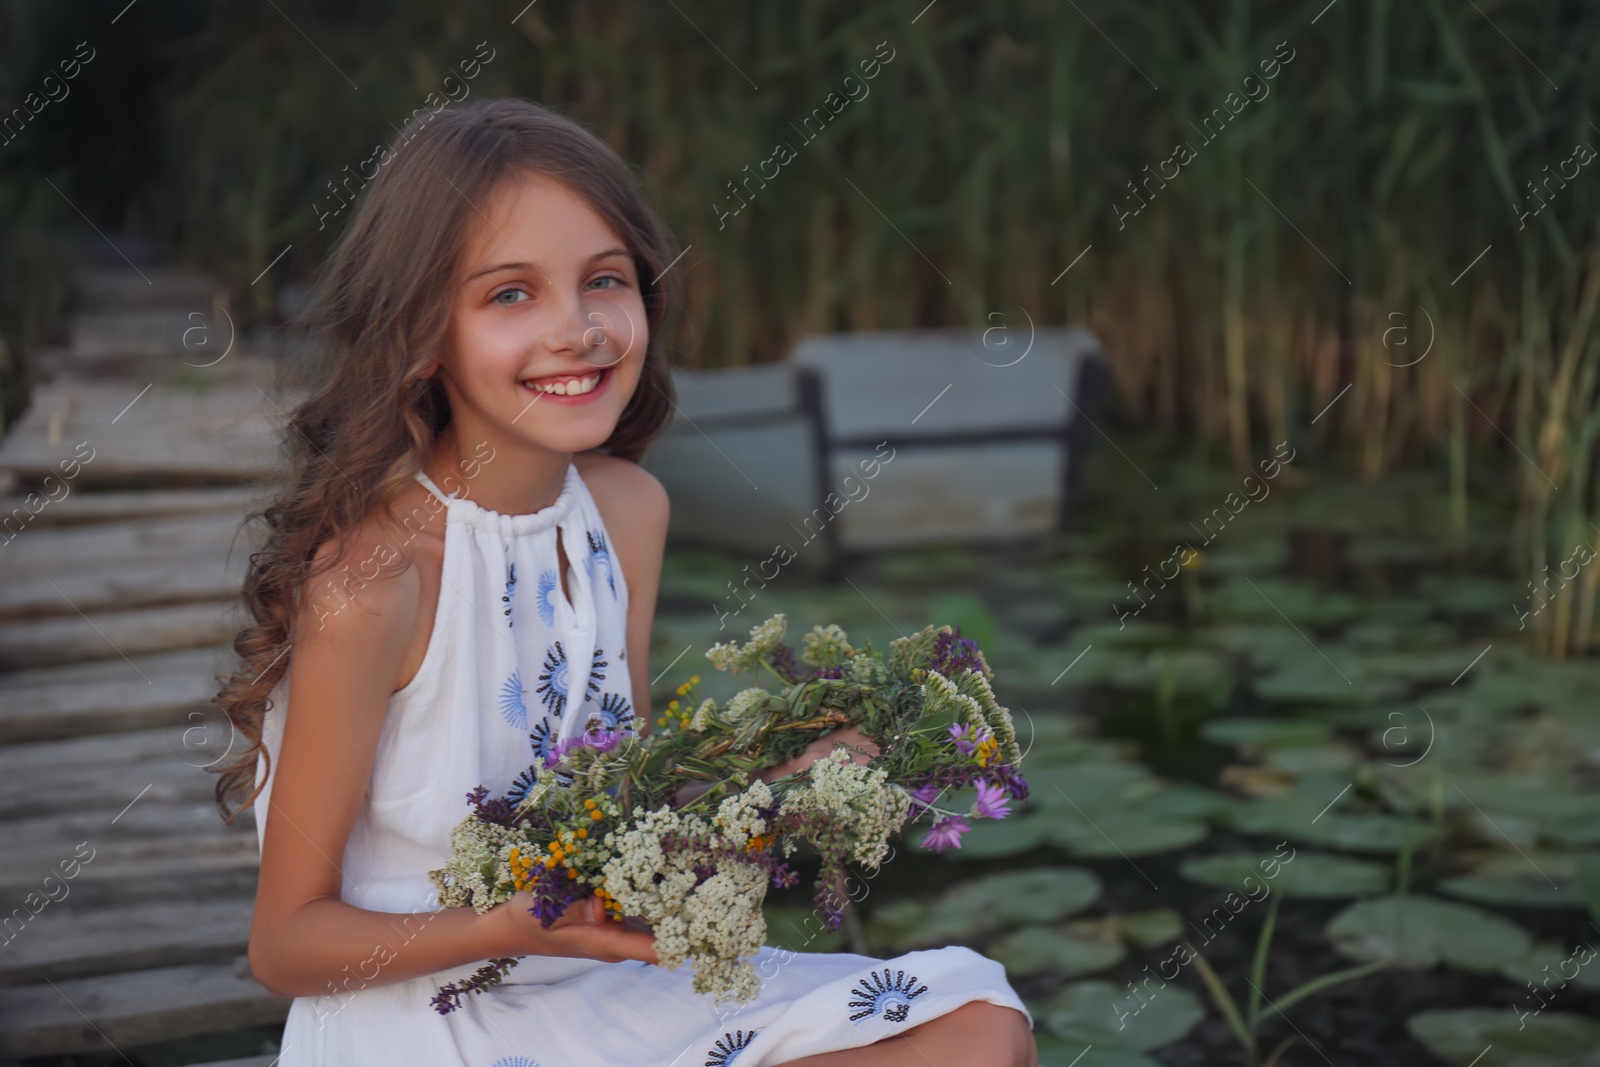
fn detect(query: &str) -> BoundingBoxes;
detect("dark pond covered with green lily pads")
[651,442,1600,1067]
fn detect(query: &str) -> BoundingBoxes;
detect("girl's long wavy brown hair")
[211,99,677,825]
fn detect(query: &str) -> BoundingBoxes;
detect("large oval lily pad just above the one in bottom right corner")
[1328,896,1533,971]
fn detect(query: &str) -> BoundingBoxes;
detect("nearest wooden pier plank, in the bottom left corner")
[0,955,291,1056]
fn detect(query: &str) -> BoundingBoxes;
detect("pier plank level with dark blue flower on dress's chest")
[0,646,235,744]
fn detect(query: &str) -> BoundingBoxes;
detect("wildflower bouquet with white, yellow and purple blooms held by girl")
[429,614,1027,1014]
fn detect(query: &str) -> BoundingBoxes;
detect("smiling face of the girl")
[440,174,650,453]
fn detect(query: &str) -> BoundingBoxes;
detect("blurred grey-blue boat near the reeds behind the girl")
[645,328,1107,569]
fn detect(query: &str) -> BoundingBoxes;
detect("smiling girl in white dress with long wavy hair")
[218,99,1035,1067]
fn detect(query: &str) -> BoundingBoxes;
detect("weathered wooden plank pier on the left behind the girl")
[0,266,294,1067]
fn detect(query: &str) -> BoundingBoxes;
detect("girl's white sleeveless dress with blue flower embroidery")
[254,466,1032,1067]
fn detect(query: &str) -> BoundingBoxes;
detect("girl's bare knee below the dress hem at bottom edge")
[774,1000,1038,1067]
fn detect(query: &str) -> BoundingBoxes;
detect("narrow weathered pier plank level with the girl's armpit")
[0,601,245,668]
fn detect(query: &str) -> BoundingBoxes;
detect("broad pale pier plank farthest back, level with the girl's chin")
[0,379,301,488]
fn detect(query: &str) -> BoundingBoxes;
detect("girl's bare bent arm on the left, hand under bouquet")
[250,524,654,1009]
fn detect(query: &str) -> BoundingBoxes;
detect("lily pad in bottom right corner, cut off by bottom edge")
[1405,1008,1600,1067]
